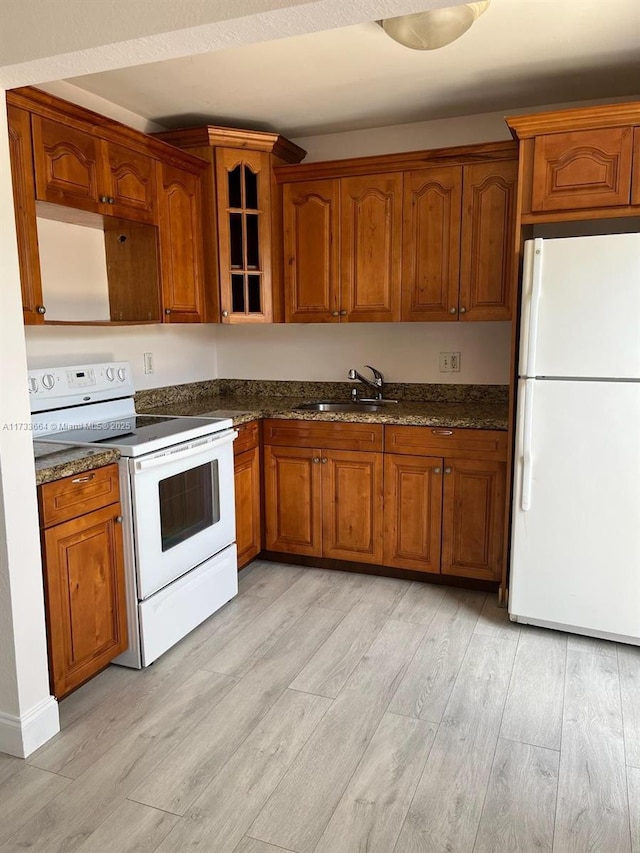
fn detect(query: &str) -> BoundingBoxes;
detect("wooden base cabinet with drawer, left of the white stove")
[38,465,128,699]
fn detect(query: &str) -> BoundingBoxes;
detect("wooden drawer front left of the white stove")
[38,465,120,527]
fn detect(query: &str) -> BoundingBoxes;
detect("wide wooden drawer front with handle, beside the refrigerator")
[384,426,508,462]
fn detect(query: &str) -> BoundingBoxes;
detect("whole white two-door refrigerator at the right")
[509,234,640,645]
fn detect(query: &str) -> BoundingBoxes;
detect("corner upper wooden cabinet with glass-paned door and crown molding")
[155,125,306,323]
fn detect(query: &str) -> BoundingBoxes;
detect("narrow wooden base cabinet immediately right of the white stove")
[233,421,262,569]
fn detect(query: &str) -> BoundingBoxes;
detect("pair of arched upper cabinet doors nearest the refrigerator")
[402,160,517,321]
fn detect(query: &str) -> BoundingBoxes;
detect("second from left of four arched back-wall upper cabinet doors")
[340,174,402,322]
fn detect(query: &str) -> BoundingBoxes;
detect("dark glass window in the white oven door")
[158,459,220,552]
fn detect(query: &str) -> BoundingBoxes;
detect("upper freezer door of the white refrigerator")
[518,234,640,379]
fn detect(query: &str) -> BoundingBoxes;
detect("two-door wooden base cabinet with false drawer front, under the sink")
[264,420,383,564]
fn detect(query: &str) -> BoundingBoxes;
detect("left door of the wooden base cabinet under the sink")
[264,447,322,557]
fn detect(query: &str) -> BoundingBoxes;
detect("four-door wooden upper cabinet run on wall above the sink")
[276,143,517,323]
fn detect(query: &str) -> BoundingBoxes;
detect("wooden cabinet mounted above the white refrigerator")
[507,102,640,223]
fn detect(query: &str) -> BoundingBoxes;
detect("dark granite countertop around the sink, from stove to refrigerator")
[140,395,509,430]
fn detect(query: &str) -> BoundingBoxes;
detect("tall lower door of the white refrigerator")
[509,380,640,644]
